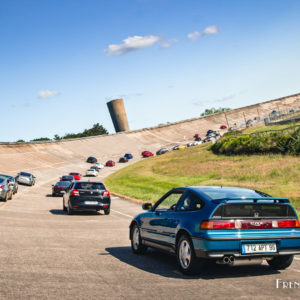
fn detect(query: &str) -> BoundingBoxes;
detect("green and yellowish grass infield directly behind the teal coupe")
[105,146,300,212]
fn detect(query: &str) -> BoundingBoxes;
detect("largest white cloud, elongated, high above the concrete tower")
[105,35,160,55]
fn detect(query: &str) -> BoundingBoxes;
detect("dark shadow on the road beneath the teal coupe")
[104,247,279,280]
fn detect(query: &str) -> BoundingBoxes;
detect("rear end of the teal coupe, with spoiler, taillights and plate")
[192,197,300,269]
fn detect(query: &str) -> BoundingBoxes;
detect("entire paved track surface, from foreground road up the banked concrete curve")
[0,95,300,300]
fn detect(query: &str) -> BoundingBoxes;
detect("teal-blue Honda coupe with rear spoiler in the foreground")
[130,186,300,274]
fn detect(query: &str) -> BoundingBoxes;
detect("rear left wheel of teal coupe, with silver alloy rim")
[176,234,201,275]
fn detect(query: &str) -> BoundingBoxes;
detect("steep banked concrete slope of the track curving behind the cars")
[0,94,300,178]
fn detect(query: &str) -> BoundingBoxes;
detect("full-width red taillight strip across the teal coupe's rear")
[200,219,300,230]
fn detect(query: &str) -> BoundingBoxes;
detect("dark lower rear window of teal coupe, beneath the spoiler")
[213,204,296,219]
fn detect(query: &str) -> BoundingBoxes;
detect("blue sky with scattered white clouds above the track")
[0,0,300,142]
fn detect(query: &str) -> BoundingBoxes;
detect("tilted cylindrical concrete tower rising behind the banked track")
[106,99,129,132]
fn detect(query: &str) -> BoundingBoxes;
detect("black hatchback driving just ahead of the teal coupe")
[63,181,110,215]
